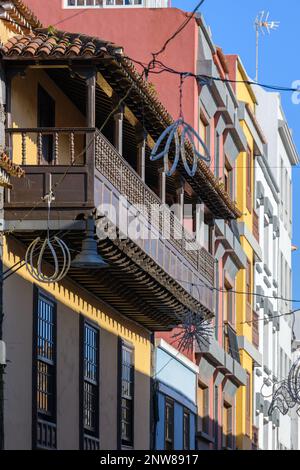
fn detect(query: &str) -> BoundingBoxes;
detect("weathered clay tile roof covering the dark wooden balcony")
[0,29,241,218]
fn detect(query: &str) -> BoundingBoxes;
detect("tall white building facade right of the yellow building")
[254,88,299,450]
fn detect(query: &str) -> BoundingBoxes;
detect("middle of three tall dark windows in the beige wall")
[82,321,99,437]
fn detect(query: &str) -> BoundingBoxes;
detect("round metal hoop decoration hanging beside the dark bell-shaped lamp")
[25,237,71,284]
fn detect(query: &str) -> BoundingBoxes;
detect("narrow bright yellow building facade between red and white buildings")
[228,56,264,450]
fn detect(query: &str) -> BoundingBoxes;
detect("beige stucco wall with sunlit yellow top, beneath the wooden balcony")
[4,237,151,450]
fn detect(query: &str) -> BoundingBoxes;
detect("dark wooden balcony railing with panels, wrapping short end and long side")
[6,128,214,311]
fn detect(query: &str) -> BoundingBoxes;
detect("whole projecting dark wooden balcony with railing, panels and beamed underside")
[5,128,214,329]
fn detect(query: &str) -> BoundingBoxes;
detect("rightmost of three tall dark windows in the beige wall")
[121,341,134,447]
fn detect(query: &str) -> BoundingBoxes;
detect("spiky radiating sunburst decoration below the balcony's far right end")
[172,310,213,351]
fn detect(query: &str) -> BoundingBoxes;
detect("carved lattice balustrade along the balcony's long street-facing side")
[95,129,214,297]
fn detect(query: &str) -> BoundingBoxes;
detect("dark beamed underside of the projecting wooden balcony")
[6,222,212,331]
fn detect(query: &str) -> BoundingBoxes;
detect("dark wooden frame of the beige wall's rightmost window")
[118,338,135,450]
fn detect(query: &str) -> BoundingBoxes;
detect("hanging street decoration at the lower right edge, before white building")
[269,357,300,416]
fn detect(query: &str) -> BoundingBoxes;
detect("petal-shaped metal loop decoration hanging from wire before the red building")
[150,118,211,177]
